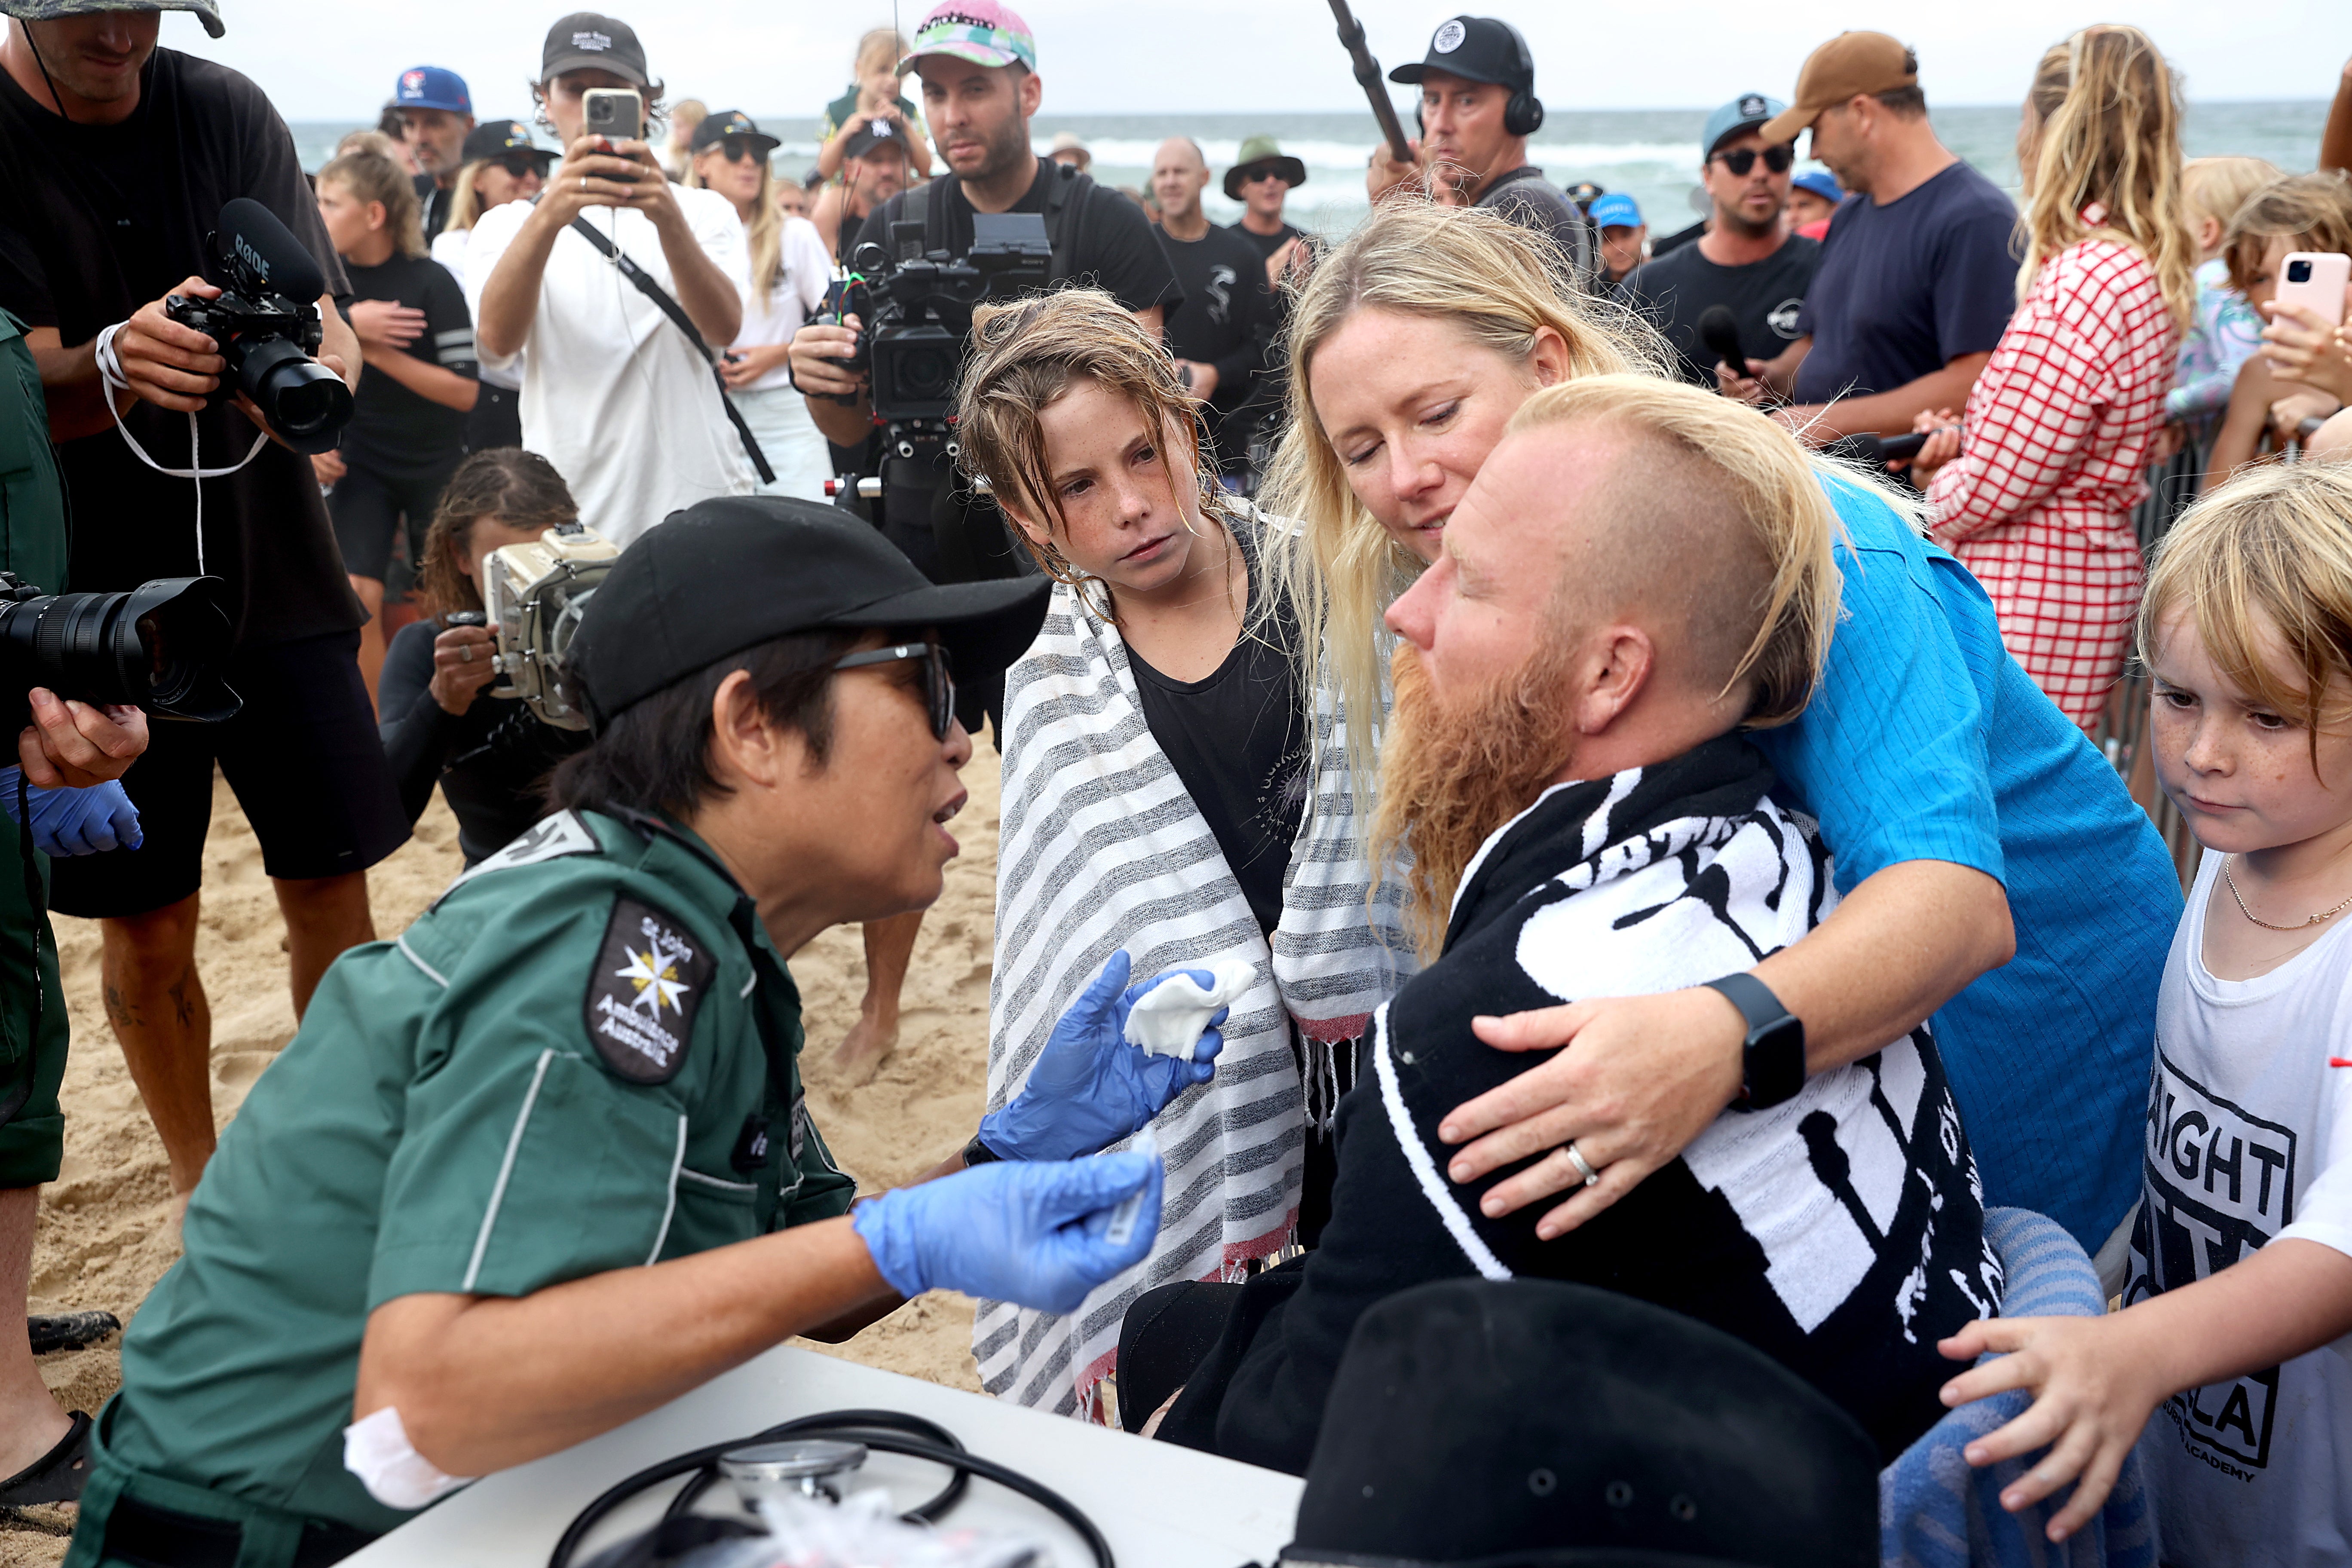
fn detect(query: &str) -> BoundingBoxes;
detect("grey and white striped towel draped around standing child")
[971,567,1414,1420]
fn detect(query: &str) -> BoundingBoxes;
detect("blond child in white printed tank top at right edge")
[1943,463,2352,1568]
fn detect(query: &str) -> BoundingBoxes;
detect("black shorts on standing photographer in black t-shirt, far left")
[49,632,409,919]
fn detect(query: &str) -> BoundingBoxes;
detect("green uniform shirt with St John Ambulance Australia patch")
[66,811,854,1568]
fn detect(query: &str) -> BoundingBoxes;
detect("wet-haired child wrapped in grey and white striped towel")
[957,289,1411,1420]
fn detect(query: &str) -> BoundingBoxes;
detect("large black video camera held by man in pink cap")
[847,211,1054,426]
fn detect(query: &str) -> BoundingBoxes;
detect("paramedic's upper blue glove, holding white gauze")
[981,947,1230,1159]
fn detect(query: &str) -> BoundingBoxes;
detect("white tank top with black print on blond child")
[2124,851,2352,1568]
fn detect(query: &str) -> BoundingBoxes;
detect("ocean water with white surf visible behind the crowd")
[294,99,2328,235]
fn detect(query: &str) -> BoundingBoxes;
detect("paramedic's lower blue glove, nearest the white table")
[851,1154,1167,1312]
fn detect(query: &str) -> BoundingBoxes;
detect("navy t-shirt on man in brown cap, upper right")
[1795,162,2018,402]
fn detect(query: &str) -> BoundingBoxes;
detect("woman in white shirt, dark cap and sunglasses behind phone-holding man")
[687,110,833,501]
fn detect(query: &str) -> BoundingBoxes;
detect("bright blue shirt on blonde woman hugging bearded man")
[1752,484,2180,1251]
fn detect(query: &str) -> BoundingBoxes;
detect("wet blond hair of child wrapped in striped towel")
[955,289,1228,623]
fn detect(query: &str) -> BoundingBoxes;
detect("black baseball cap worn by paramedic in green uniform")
[569,496,1054,729]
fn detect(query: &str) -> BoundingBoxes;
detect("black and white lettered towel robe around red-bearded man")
[1162,736,2002,1472]
